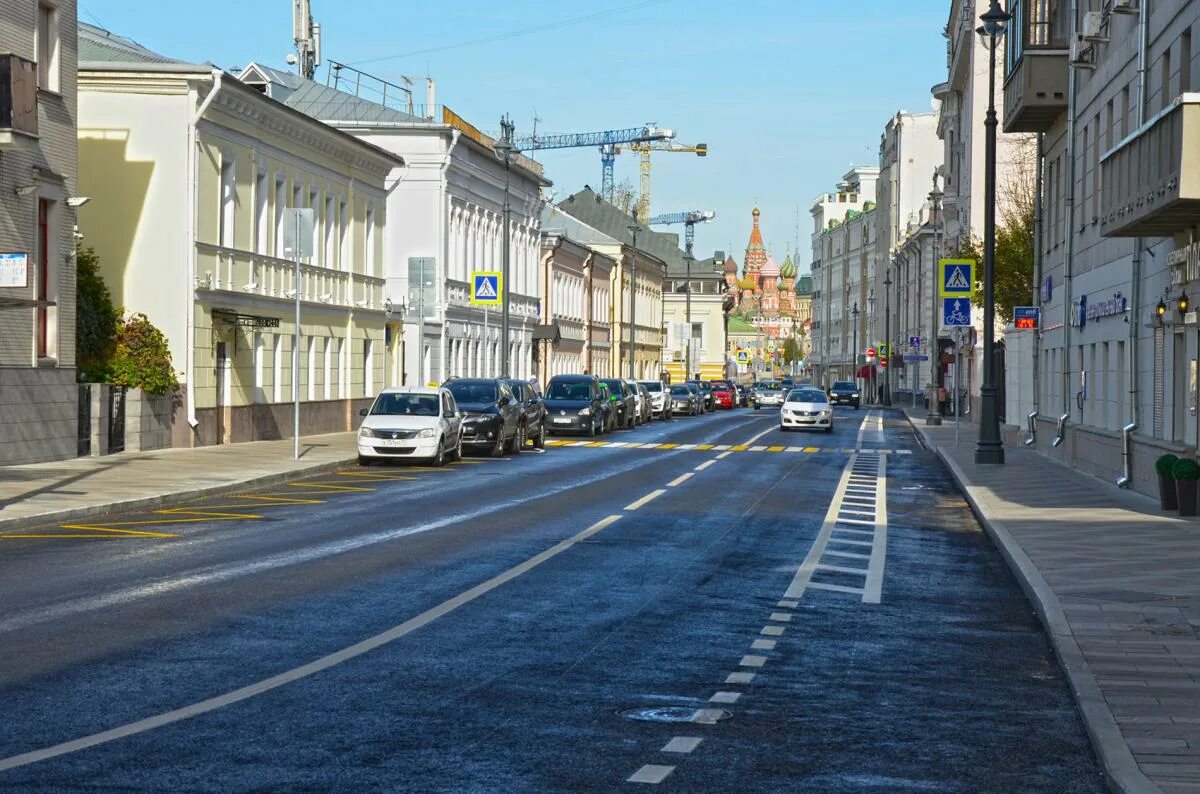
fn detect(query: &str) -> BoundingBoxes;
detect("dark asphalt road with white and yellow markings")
[0,409,1104,793]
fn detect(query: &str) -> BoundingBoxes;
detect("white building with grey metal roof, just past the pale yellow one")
[240,64,550,385]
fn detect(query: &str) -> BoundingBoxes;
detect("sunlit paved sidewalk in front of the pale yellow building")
[0,432,356,534]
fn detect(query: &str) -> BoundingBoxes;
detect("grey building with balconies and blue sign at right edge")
[1002,0,1200,492]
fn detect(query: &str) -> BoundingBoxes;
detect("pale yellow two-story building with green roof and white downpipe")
[78,25,401,446]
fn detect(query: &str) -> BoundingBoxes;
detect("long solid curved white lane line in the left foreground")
[0,516,620,771]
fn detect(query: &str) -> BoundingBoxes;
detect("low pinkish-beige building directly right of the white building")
[544,205,620,384]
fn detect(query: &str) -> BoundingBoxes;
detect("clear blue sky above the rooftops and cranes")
[79,0,949,271]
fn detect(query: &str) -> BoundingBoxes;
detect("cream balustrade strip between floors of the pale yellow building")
[196,242,385,309]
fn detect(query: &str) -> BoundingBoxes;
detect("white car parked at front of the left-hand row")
[358,387,462,465]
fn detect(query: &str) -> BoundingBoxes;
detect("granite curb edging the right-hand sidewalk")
[905,414,1162,794]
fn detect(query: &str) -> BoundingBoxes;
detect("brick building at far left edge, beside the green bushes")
[0,0,83,464]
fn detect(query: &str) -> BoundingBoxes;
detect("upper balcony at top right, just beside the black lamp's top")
[1004,0,1069,132]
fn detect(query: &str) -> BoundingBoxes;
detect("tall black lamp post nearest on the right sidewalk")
[976,0,1012,463]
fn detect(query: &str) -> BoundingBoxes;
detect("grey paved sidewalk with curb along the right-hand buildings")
[905,407,1200,794]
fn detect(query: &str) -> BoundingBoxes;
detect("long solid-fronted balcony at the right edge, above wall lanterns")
[1099,94,1200,237]
